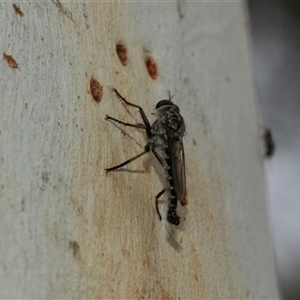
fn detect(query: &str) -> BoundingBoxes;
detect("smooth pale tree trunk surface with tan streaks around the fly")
[0,0,278,299]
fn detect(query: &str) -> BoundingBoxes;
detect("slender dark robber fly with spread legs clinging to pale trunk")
[105,89,186,226]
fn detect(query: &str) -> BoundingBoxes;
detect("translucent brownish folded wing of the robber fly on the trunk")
[168,138,186,205]
